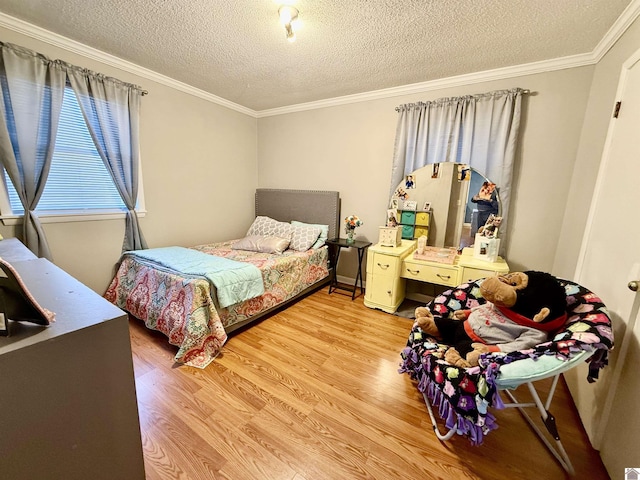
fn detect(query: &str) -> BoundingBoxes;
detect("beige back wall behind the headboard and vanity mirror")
[258,67,593,277]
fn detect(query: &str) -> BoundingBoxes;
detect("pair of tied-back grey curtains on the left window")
[0,42,147,259]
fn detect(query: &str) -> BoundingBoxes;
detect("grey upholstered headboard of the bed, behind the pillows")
[256,188,340,238]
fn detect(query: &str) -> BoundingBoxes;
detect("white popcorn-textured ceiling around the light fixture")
[0,0,631,111]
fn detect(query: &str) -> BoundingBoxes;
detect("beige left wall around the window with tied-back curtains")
[0,28,257,294]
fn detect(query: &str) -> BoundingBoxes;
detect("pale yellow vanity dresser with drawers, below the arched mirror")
[364,240,509,313]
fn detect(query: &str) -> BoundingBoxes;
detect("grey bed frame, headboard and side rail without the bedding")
[225,188,340,334]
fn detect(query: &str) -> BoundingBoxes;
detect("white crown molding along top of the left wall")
[0,12,257,118]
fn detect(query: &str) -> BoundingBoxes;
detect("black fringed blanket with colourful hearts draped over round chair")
[400,280,613,445]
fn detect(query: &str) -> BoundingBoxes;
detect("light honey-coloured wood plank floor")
[130,288,609,480]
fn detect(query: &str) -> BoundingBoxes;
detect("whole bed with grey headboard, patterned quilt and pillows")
[104,189,340,368]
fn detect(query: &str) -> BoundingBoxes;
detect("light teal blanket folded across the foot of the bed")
[125,247,264,308]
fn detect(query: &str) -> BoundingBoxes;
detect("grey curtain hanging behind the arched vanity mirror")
[389,88,525,249]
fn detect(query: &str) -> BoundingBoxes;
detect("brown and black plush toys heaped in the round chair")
[415,271,567,368]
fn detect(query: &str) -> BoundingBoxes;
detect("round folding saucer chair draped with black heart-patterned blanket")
[400,279,613,474]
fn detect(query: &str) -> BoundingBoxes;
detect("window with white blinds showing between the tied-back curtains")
[0,86,142,218]
